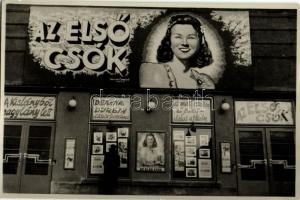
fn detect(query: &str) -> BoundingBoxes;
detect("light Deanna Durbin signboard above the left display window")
[91,96,130,121]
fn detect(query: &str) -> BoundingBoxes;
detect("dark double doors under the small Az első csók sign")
[236,128,295,196]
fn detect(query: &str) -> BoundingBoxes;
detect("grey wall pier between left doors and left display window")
[52,92,90,183]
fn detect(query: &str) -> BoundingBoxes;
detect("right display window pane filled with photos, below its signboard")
[172,127,214,180]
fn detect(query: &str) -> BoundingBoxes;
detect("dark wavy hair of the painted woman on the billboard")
[156,15,212,67]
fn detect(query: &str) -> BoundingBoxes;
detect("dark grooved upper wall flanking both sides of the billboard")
[5,5,297,91]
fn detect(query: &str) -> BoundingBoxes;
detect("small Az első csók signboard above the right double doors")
[235,101,294,125]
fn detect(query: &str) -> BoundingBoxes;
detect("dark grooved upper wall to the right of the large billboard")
[249,10,297,91]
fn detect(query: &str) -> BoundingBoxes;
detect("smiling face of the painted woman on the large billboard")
[171,24,199,60]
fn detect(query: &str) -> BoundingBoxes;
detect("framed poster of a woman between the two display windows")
[136,132,166,172]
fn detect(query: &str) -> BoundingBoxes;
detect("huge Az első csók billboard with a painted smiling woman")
[24,6,252,89]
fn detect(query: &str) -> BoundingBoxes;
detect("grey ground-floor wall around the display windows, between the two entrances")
[51,92,237,195]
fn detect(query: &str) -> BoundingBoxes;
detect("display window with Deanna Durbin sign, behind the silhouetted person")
[88,95,131,178]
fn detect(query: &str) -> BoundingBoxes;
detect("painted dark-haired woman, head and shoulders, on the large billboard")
[140,15,224,89]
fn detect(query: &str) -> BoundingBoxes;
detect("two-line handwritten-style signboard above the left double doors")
[4,95,56,120]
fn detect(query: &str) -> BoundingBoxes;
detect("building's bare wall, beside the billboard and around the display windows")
[5,5,296,195]
